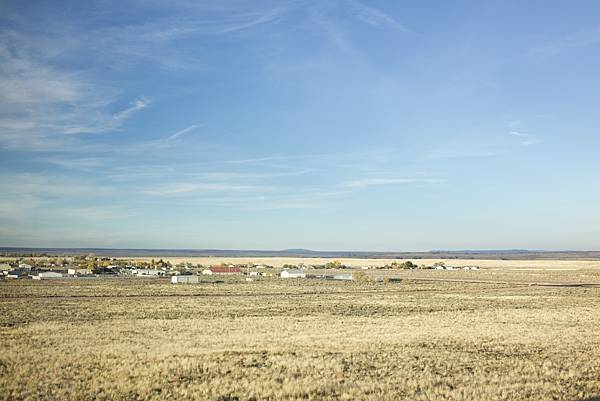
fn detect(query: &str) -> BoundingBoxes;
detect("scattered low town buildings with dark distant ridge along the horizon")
[0,247,600,283]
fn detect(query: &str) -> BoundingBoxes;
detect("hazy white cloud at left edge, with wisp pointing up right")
[0,30,149,151]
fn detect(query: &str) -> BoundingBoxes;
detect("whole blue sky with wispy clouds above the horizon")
[0,0,600,251]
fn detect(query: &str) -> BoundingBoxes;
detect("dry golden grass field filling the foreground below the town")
[0,262,600,401]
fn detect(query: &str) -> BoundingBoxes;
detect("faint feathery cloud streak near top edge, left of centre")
[82,2,290,71]
